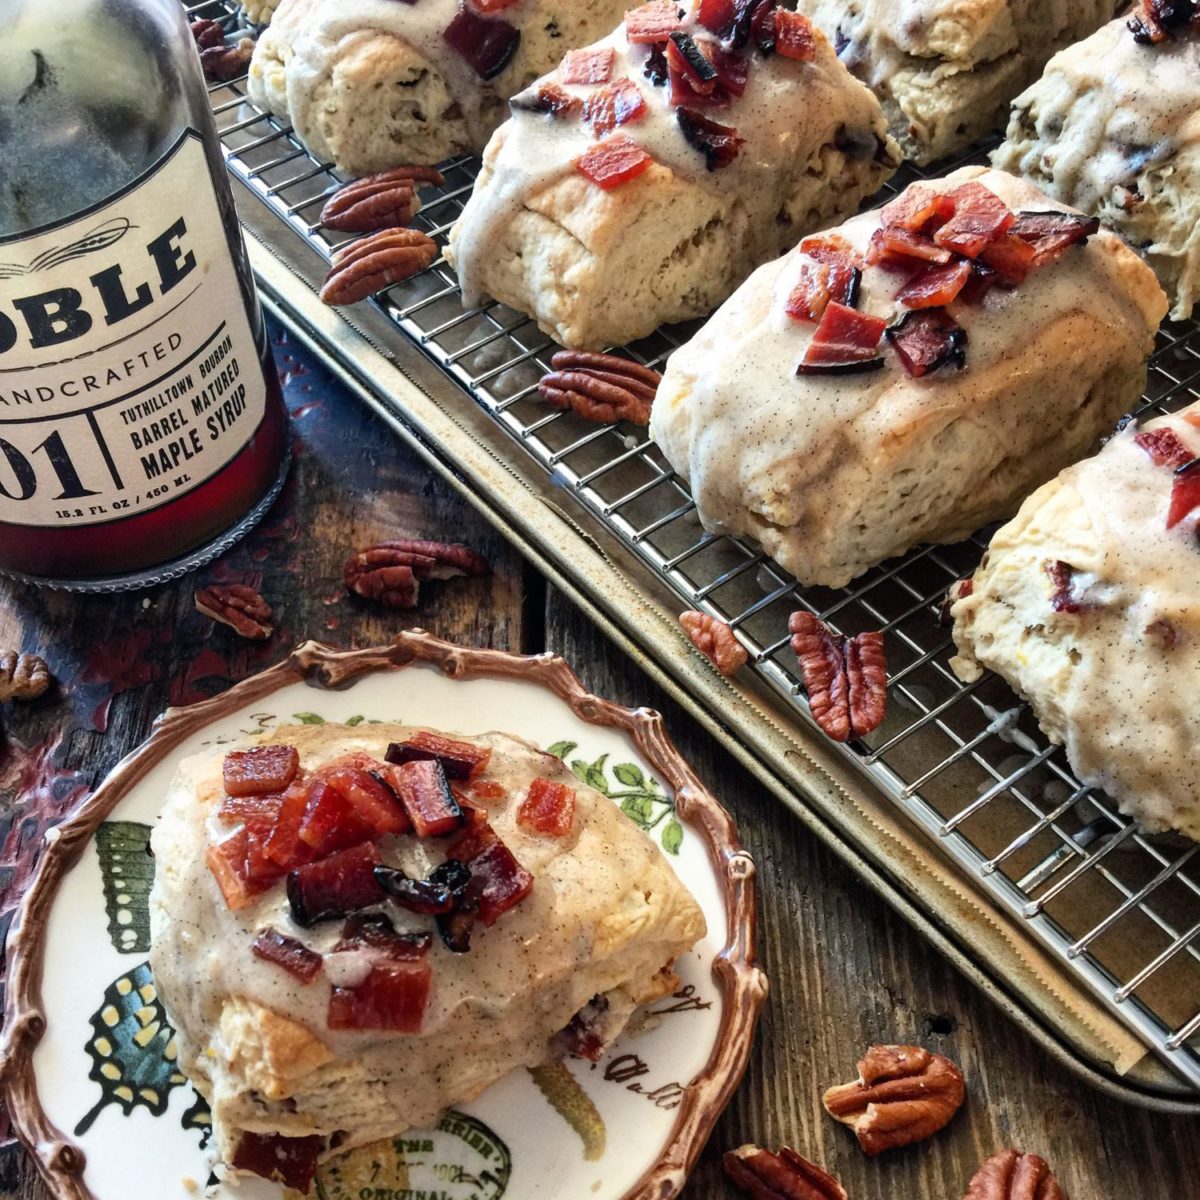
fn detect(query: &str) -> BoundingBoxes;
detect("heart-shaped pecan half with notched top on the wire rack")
[787,610,888,742]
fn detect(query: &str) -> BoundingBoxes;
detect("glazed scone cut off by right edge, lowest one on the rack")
[950,404,1200,840]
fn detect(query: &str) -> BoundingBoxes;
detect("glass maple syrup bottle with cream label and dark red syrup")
[0,0,288,590]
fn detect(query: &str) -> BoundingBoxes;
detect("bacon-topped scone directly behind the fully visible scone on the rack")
[446,0,899,349]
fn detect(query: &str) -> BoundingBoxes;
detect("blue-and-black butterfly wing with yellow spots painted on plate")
[74,962,187,1135]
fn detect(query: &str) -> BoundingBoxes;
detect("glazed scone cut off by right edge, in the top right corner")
[992,18,1200,320]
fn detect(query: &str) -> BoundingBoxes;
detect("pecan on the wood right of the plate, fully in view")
[823,1046,965,1154]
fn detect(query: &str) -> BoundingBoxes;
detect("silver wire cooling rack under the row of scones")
[187,0,1200,1092]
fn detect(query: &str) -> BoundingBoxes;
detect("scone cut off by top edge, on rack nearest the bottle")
[247,0,626,175]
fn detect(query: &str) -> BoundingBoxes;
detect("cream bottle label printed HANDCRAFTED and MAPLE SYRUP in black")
[0,130,266,527]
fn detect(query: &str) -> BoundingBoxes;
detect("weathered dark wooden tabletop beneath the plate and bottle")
[0,321,1200,1200]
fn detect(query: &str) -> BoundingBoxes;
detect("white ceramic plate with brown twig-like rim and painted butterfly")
[0,632,766,1200]
